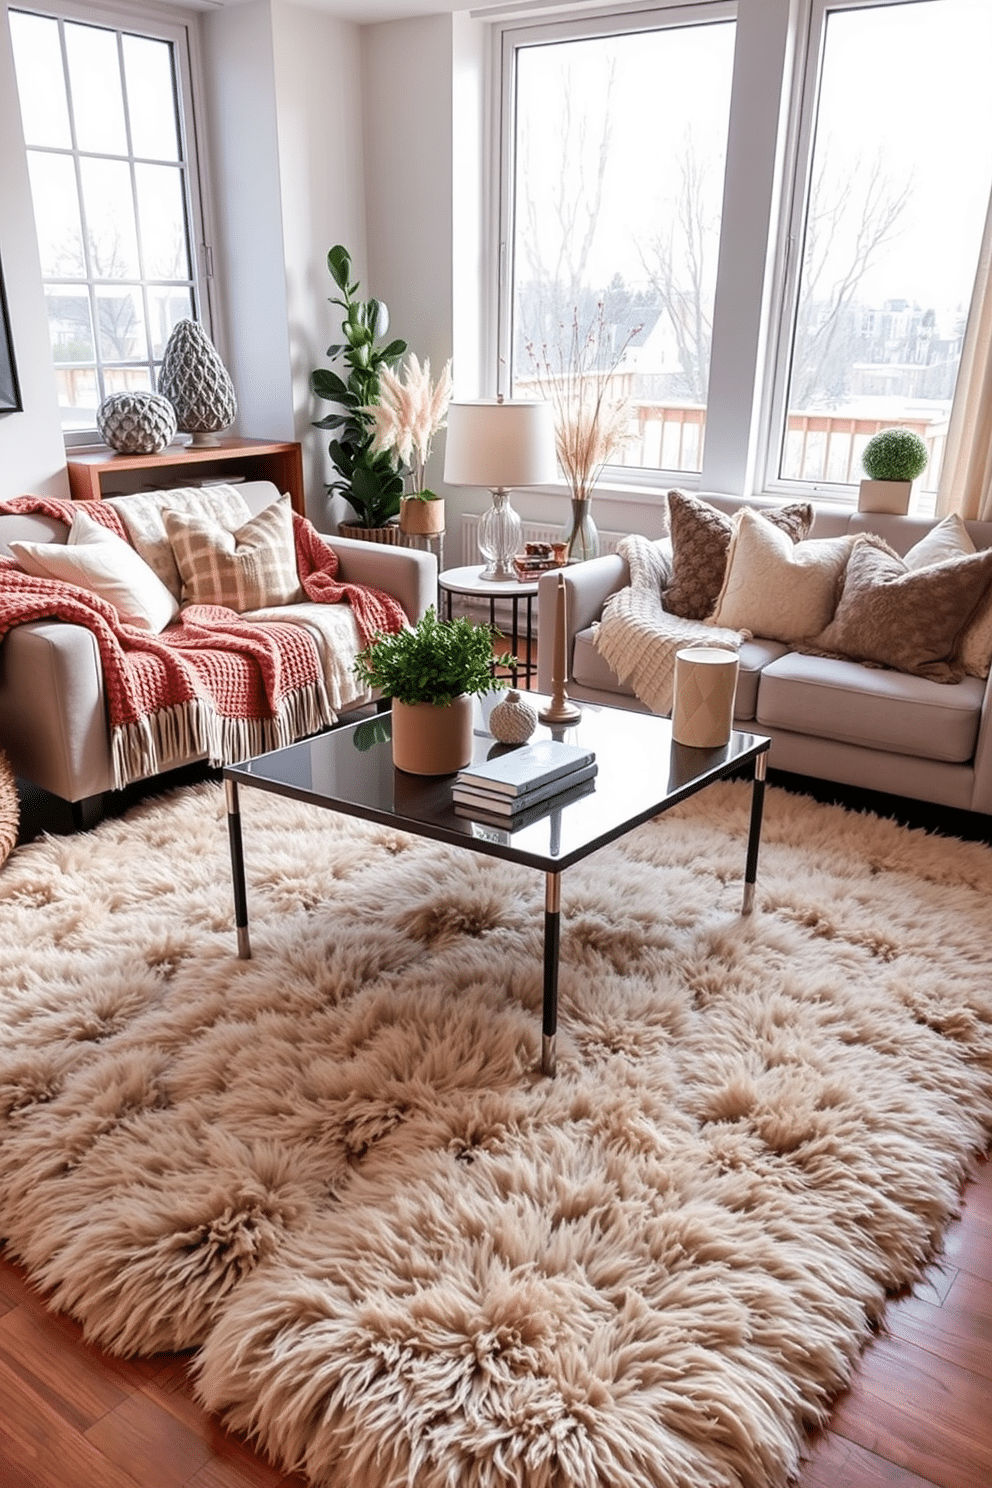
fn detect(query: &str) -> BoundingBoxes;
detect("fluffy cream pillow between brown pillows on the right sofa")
[712,507,854,641]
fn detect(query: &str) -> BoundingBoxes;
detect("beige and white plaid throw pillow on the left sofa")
[162,496,303,615]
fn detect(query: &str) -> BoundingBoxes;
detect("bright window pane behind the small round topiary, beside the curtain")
[781,0,992,491]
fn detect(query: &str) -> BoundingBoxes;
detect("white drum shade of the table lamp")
[445,397,558,491]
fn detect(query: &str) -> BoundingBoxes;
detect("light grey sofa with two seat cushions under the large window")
[538,494,992,814]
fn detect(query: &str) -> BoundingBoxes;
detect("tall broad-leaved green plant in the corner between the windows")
[309,244,406,542]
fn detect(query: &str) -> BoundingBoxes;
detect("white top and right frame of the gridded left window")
[10,0,217,449]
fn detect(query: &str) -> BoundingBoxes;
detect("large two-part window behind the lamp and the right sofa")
[498,0,992,509]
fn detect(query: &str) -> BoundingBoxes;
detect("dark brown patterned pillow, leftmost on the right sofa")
[662,491,814,620]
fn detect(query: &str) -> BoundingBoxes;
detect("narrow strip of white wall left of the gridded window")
[0,6,68,500]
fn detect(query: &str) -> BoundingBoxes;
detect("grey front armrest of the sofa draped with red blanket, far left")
[0,620,113,801]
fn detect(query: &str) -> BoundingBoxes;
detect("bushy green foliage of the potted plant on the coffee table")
[354,606,512,708]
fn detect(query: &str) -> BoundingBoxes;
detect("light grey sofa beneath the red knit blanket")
[0,481,437,823]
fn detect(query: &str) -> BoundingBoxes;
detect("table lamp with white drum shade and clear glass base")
[445,397,558,580]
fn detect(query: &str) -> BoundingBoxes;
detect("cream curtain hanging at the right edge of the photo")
[937,186,992,521]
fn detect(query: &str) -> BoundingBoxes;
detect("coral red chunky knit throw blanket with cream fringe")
[0,496,406,789]
